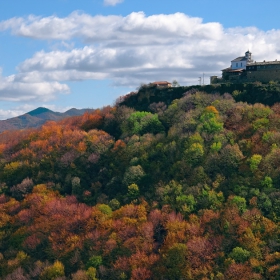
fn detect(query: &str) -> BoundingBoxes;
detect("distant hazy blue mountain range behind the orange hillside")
[0,107,93,132]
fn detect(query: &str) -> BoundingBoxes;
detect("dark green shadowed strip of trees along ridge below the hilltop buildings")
[118,81,280,111]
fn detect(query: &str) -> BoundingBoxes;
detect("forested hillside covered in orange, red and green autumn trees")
[0,87,280,280]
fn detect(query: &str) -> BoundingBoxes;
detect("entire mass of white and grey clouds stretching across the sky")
[0,11,280,100]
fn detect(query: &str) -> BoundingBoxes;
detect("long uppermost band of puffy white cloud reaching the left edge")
[0,12,223,42]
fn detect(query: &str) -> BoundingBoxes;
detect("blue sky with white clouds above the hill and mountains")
[0,0,280,120]
